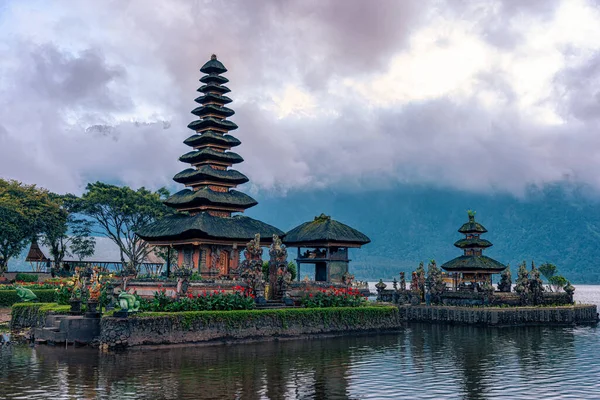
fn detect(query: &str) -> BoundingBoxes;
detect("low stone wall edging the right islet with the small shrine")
[398,305,598,326]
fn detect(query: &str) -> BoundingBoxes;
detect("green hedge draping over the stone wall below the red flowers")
[135,306,399,330]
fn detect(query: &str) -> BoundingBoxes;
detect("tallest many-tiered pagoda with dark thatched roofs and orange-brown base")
[137,55,283,277]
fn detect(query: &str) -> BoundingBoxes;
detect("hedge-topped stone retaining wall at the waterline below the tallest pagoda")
[100,306,401,348]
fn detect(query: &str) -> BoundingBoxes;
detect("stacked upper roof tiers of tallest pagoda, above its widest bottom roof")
[165,54,258,217]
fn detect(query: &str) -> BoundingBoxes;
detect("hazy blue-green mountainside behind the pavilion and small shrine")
[248,184,600,283]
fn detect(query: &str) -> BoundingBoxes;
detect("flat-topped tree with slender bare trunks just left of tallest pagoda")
[81,182,173,272]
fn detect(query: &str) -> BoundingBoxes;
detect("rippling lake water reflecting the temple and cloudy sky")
[0,285,600,399]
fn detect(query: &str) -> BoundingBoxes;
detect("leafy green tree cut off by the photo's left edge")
[0,179,57,274]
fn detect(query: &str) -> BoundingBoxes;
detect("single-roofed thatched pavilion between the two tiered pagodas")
[283,214,371,282]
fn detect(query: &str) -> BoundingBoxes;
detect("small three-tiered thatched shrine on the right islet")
[442,211,506,289]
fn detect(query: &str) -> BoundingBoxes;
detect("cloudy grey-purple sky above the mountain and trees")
[0,0,600,195]
